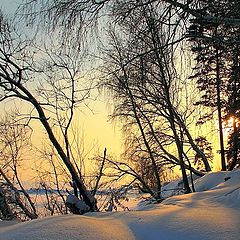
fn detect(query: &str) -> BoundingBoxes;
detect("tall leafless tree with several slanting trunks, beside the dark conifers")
[100,0,213,192]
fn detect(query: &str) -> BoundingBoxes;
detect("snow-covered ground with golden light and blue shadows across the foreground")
[0,170,240,240]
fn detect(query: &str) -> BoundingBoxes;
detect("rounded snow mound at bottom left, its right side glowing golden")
[0,215,134,240]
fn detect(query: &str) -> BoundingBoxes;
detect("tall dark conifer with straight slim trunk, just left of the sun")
[189,0,231,170]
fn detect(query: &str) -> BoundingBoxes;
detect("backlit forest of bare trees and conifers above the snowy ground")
[0,0,240,221]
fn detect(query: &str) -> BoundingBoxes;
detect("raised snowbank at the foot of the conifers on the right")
[162,169,240,209]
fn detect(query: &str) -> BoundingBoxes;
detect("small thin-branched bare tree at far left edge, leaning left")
[0,115,38,219]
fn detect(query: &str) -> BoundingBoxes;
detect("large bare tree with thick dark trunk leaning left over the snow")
[0,11,96,211]
